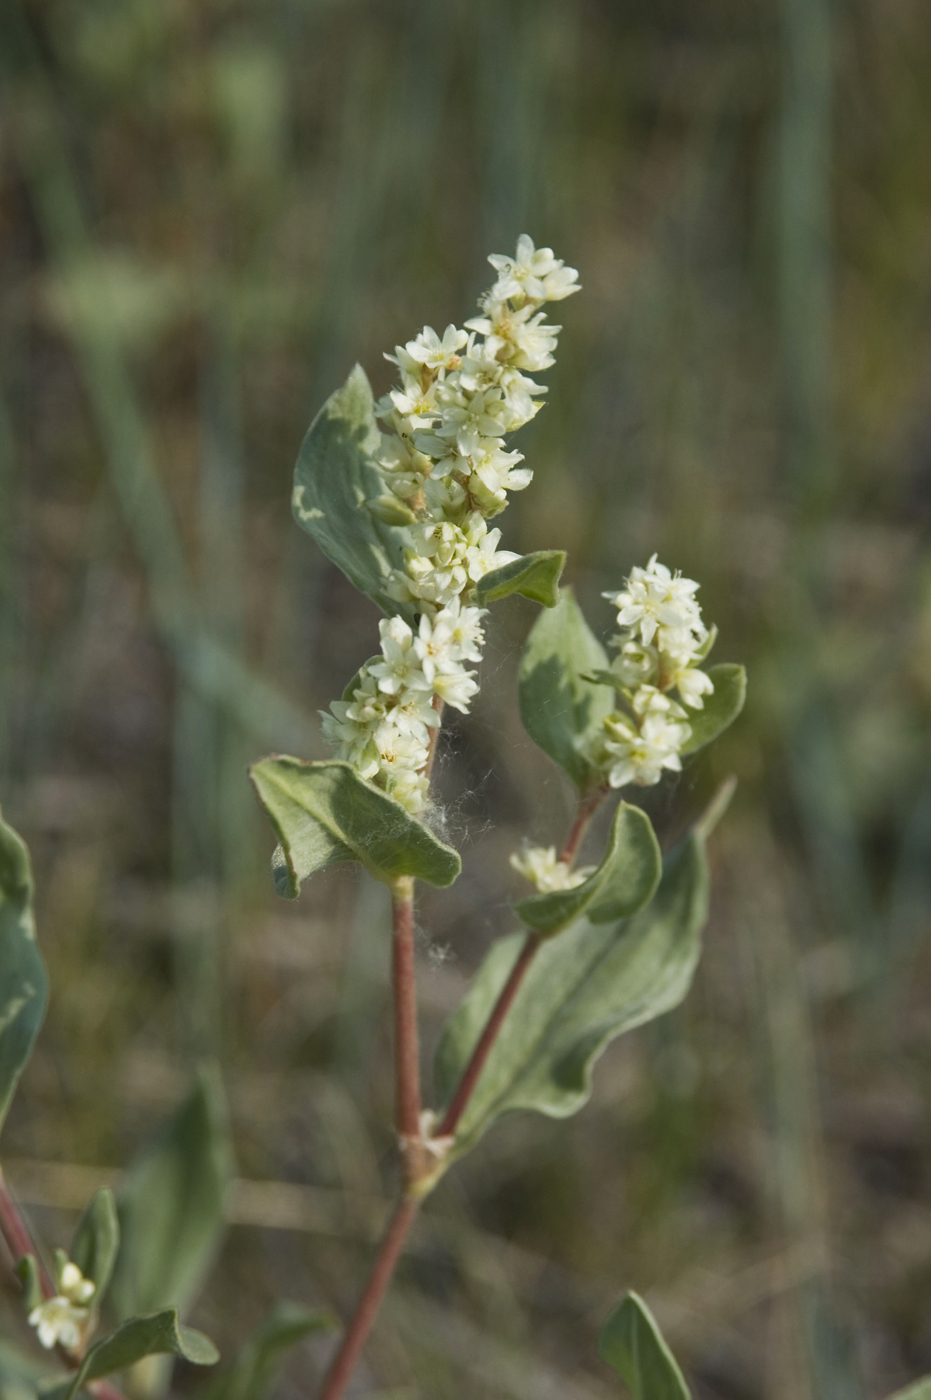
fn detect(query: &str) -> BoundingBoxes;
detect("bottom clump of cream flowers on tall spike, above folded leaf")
[323,598,484,812]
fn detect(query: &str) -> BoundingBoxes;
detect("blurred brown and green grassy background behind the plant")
[0,0,931,1400]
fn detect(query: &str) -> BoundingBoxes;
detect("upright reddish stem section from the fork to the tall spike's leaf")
[392,878,423,1189]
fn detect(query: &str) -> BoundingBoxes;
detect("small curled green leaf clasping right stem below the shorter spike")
[514,802,662,937]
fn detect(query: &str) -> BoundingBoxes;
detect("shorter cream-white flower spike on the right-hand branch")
[590,554,714,787]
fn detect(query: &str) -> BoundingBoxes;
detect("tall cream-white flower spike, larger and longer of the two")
[323,235,580,812]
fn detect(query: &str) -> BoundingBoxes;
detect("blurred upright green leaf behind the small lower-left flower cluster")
[112,1071,232,1317]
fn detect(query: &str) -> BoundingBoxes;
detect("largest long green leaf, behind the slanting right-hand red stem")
[435,833,708,1158]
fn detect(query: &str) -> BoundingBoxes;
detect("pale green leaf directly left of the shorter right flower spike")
[519,588,615,788]
